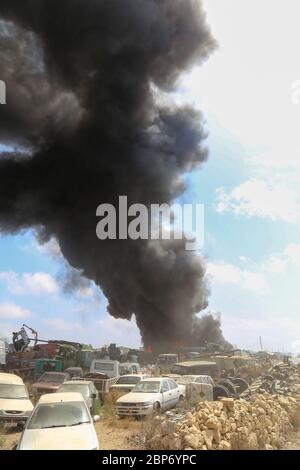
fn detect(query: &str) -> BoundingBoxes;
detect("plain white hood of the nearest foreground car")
[19,424,99,450]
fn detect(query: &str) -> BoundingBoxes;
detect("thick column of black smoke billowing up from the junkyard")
[0,0,230,344]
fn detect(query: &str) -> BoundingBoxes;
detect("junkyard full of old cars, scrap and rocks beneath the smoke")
[0,325,300,450]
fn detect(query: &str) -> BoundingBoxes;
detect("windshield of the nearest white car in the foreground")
[27,401,91,429]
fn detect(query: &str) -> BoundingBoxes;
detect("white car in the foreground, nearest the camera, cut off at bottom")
[17,392,99,450]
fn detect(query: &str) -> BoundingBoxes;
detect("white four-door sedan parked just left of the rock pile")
[116,377,183,417]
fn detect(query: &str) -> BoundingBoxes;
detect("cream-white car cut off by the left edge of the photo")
[0,373,33,423]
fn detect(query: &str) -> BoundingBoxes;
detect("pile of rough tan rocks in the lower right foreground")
[144,393,299,450]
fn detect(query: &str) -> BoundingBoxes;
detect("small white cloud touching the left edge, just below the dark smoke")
[0,271,58,295]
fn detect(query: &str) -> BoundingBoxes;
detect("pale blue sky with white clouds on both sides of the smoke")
[0,0,300,352]
